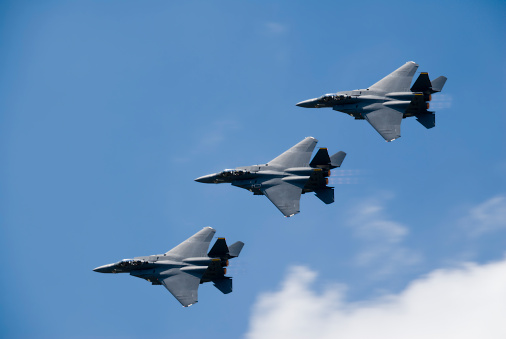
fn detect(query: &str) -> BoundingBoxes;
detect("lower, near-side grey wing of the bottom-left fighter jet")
[160,270,200,307]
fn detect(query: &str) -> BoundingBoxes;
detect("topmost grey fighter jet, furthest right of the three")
[296,61,446,142]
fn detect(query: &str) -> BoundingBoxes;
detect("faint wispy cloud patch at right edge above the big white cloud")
[461,195,506,235]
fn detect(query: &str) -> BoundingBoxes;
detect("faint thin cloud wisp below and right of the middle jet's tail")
[348,194,422,278]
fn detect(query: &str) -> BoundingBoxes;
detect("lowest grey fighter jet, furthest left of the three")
[93,227,244,307]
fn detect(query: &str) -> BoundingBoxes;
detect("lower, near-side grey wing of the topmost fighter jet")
[364,107,403,141]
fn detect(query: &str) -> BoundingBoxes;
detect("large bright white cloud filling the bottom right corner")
[246,260,506,339]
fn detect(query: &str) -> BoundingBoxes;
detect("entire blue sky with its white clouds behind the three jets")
[0,0,506,339]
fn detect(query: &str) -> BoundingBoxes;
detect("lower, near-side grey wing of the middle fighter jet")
[262,181,302,217]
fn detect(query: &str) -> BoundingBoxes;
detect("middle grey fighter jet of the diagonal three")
[195,137,346,217]
